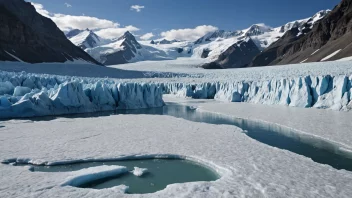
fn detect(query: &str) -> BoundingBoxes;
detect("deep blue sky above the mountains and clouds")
[33,0,340,40]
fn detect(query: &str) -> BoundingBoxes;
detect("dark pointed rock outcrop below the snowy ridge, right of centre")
[203,37,260,69]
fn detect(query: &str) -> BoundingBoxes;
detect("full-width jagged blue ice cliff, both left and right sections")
[0,71,352,118]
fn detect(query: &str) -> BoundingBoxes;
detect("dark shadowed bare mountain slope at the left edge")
[0,0,100,65]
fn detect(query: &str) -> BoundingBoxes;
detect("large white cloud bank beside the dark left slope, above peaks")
[32,3,139,39]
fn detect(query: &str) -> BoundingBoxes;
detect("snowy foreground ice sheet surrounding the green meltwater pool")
[0,115,352,198]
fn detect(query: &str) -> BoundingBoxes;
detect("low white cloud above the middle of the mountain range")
[161,25,218,41]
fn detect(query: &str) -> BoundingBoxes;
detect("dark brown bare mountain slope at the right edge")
[250,0,352,66]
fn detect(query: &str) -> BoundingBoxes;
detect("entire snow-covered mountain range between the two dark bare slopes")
[66,10,329,65]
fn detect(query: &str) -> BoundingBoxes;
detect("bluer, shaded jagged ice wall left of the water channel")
[0,72,164,118]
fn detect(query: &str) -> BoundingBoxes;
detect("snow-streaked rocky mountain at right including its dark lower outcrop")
[201,10,330,69]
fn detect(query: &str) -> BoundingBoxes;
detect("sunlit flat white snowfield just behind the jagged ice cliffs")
[109,58,352,82]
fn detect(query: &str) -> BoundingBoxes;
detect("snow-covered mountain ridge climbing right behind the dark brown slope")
[202,10,330,68]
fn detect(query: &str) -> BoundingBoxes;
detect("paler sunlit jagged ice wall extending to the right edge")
[160,75,352,111]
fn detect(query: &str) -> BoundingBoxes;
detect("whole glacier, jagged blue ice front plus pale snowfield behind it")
[0,59,352,118]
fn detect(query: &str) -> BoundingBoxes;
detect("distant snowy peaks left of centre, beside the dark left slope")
[66,30,191,65]
